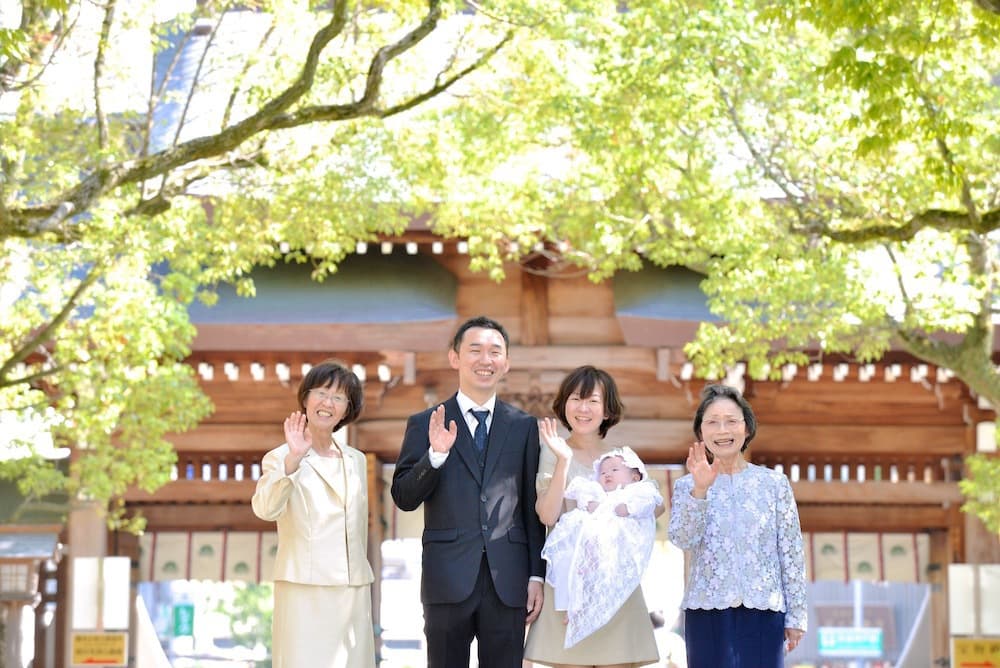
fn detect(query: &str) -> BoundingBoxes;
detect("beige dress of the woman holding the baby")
[524,447,660,666]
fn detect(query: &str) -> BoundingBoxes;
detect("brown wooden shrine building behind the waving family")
[76,231,1000,657]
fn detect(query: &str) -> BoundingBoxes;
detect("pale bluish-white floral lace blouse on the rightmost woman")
[669,464,807,631]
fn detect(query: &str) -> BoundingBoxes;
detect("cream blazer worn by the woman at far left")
[251,444,375,586]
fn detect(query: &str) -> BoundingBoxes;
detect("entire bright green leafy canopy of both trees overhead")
[0,0,1000,532]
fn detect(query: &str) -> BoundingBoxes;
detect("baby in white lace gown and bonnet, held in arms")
[542,447,663,647]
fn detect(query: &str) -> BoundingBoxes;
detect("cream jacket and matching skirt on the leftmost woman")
[253,445,375,668]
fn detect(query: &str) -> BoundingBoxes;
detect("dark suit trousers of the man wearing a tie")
[424,552,528,668]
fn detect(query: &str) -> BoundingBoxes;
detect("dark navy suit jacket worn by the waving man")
[392,395,545,607]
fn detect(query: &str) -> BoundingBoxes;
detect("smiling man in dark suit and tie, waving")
[392,316,545,668]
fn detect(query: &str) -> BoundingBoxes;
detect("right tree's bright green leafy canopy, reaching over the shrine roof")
[386,0,1000,530]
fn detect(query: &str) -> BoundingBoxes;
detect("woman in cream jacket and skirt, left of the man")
[252,360,375,668]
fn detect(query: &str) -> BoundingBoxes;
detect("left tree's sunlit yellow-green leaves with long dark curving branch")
[0,0,598,529]
